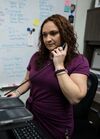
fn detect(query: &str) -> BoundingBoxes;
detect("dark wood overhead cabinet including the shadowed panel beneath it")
[84,8,100,66]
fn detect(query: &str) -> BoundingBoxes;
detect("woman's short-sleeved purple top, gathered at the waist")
[26,53,89,139]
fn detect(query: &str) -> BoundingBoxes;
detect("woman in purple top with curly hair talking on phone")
[5,14,89,139]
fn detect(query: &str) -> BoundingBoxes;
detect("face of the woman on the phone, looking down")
[42,21,61,51]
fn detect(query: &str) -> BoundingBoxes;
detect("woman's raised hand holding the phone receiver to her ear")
[51,44,68,70]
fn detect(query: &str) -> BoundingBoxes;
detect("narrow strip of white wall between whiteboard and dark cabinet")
[75,0,91,53]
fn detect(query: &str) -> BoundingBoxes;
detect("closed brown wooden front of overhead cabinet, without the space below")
[85,8,100,41]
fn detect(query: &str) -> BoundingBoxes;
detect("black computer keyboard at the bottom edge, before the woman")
[13,120,51,139]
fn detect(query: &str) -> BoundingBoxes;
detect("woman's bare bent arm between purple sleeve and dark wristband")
[57,72,87,104]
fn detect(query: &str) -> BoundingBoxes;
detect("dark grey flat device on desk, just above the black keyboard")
[0,97,33,130]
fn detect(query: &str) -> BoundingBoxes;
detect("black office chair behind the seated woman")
[72,72,98,139]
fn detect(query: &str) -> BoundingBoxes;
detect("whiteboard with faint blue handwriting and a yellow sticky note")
[0,0,77,88]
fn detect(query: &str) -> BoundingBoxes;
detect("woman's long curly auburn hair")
[36,14,78,68]
